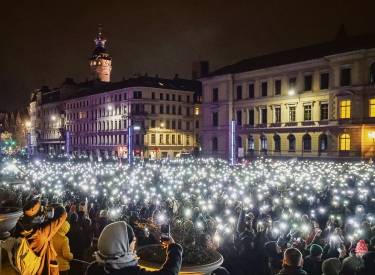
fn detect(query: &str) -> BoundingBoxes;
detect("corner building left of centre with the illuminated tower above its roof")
[30,29,202,158]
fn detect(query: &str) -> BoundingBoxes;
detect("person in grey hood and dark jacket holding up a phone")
[86,221,182,275]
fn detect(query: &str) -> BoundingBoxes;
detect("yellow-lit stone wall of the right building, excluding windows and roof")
[201,49,375,159]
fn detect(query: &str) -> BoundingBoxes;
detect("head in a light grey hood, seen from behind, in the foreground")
[95,221,137,269]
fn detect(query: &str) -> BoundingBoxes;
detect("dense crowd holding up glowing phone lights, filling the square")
[0,159,375,275]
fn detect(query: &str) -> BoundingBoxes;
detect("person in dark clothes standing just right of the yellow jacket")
[66,213,85,274]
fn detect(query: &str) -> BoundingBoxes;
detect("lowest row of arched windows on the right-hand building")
[212,134,350,152]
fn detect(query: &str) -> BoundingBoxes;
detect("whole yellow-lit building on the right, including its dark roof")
[200,29,375,159]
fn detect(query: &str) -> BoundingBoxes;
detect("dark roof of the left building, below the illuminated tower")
[68,76,202,99]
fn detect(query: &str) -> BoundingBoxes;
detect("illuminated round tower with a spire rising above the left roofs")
[89,25,112,82]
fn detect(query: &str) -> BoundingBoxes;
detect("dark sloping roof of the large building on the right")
[207,27,375,78]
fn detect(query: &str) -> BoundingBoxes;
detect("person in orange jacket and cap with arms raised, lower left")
[15,200,67,275]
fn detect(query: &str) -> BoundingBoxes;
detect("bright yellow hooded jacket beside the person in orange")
[52,221,73,271]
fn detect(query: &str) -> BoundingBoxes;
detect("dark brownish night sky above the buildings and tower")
[0,0,375,111]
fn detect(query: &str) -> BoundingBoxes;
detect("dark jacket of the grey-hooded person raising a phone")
[86,244,182,275]
